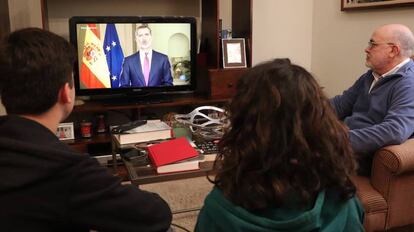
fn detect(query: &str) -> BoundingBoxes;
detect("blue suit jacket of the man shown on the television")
[120,50,173,87]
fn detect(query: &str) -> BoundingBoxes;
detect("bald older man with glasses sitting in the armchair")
[331,24,414,175]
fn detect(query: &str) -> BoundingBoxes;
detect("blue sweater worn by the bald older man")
[331,60,414,153]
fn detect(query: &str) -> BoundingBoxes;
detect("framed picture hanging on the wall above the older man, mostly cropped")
[341,0,414,11]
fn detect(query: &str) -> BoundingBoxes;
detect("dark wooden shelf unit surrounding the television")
[40,0,252,152]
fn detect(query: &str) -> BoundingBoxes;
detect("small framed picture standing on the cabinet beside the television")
[221,38,246,68]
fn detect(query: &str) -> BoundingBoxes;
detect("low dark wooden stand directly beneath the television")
[64,95,230,155]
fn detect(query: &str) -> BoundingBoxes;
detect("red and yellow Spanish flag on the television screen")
[80,24,111,89]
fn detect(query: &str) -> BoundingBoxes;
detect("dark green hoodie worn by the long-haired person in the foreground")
[195,188,364,232]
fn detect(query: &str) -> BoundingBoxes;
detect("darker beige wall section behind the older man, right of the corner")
[311,0,414,96]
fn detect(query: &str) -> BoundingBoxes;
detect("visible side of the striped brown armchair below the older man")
[370,139,414,229]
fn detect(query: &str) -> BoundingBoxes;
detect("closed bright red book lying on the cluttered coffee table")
[148,137,198,167]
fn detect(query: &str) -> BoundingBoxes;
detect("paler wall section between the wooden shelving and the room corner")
[252,0,314,69]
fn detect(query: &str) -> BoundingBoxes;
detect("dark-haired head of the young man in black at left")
[0,28,76,117]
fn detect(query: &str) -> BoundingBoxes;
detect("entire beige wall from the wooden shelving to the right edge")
[253,0,414,96]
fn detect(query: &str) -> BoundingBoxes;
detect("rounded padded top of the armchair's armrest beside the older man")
[373,139,414,175]
